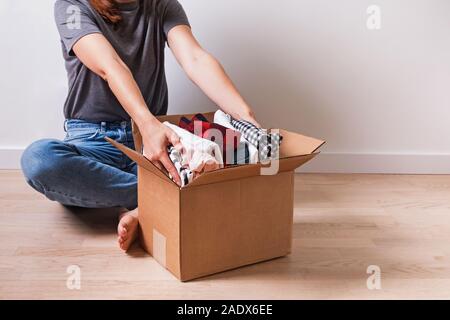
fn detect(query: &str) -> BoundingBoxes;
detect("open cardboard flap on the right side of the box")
[280,129,325,158]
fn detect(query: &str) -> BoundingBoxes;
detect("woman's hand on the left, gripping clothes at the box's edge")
[139,119,183,186]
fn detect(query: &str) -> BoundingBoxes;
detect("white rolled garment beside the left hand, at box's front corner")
[164,122,223,174]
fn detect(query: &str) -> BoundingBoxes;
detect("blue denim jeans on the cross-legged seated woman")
[21,120,137,210]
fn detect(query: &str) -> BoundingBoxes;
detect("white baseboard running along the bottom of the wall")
[0,148,450,174]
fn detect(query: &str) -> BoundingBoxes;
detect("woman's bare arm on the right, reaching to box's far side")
[168,25,259,126]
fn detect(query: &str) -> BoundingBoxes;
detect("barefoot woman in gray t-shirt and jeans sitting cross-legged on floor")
[21,0,256,251]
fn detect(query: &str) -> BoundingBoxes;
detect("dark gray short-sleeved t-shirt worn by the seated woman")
[55,0,189,122]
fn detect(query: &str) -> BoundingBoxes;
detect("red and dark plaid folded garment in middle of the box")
[179,113,245,164]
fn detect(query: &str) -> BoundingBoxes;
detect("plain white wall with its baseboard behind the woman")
[0,0,450,173]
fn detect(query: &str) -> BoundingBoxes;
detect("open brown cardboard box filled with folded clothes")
[109,113,324,281]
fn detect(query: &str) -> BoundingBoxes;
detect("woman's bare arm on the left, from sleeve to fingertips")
[73,33,182,185]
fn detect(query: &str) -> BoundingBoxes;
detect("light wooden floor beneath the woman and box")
[0,171,450,299]
